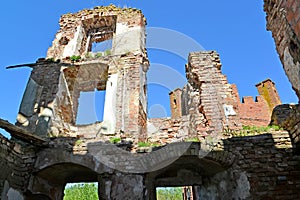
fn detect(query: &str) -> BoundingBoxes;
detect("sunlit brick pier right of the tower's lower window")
[115,54,148,140]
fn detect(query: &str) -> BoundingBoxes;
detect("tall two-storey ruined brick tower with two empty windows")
[18,6,148,140]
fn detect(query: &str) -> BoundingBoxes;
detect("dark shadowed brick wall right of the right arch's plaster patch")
[224,132,300,199]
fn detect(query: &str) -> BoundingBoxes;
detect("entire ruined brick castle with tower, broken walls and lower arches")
[0,0,300,200]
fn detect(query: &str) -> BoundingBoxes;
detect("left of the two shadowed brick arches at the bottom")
[27,148,104,199]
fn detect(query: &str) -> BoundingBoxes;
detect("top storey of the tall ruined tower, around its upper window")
[47,5,146,59]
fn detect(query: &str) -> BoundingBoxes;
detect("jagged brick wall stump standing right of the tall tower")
[154,51,241,144]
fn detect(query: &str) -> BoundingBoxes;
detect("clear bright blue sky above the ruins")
[0,0,297,136]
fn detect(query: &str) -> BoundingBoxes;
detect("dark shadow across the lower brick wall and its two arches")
[15,132,300,199]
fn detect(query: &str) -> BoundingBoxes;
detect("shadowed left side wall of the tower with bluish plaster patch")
[17,60,61,136]
